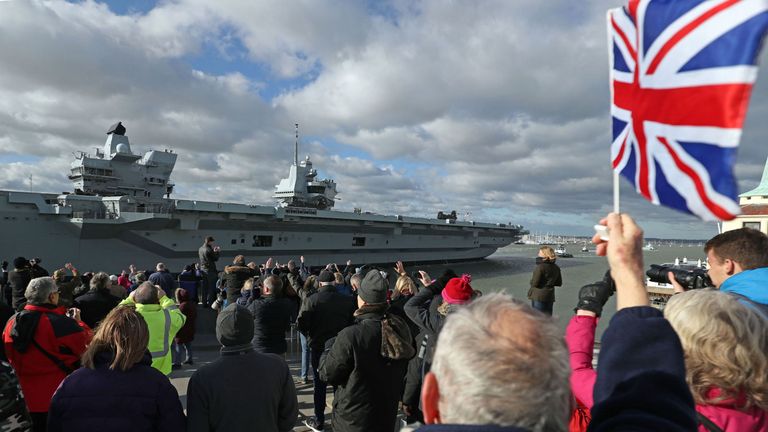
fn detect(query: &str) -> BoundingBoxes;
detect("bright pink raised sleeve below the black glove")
[565,315,598,409]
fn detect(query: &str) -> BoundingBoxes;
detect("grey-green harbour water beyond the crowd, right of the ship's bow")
[414,244,706,338]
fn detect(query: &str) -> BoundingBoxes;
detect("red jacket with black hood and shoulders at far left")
[3,304,91,413]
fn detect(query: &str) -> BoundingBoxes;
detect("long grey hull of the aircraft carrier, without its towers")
[0,191,524,272]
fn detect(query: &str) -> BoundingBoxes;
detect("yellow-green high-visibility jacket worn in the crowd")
[120,297,187,375]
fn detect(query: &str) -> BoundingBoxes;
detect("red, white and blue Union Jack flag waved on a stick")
[607,0,768,220]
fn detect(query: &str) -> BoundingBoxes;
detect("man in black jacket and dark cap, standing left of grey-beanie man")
[298,270,356,431]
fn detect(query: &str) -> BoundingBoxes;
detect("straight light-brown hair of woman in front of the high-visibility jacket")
[82,306,149,371]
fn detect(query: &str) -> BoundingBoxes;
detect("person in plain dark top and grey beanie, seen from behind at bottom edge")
[187,304,299,432]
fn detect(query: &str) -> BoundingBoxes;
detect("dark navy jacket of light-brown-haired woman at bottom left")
[48,353,186,432]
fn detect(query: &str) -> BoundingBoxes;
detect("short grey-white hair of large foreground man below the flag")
[432,294,571,432]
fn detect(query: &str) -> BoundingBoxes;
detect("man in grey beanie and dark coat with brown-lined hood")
[319,270,415,432]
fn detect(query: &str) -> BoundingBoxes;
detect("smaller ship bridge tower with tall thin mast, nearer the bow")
[272,123,337,210]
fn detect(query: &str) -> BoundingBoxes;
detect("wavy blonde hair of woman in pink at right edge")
[664,289,768,410]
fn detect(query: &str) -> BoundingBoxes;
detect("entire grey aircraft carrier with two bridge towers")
[0,123,525,273]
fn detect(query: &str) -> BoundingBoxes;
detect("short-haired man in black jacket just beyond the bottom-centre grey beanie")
[247,276,296,355]
